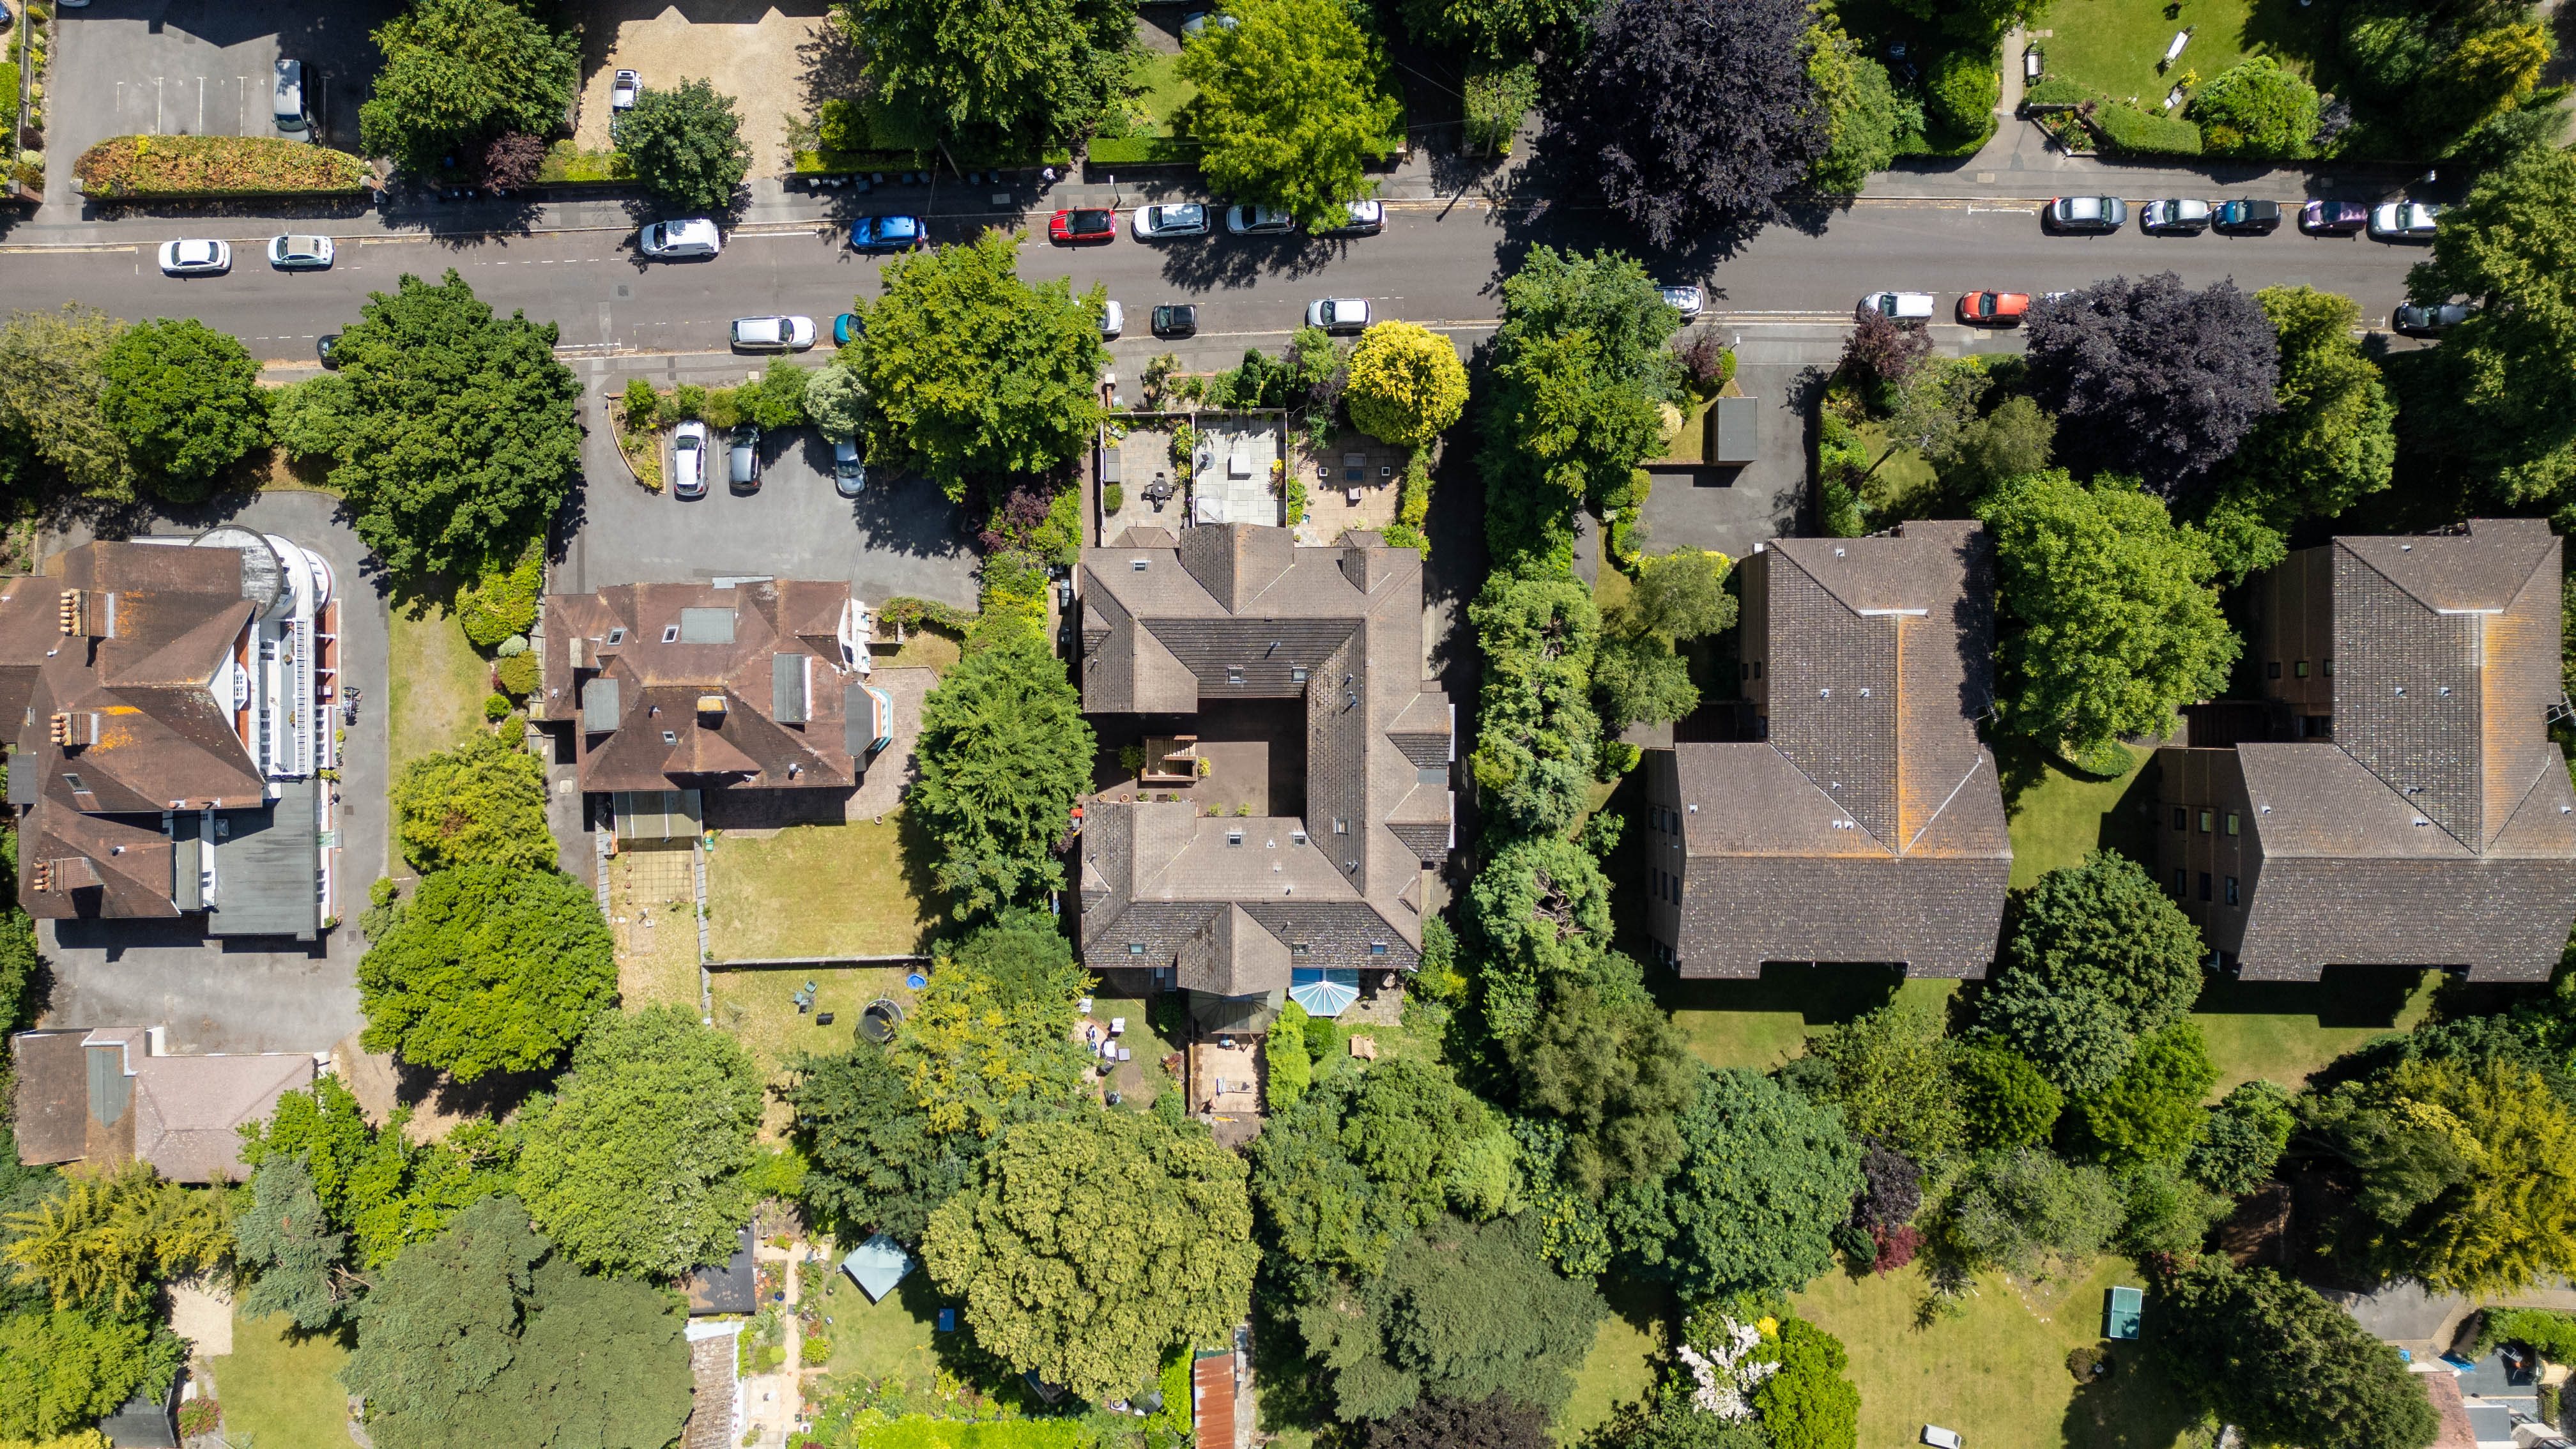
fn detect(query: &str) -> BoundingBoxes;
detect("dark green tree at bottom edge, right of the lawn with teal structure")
[2141,1258,2439,1449]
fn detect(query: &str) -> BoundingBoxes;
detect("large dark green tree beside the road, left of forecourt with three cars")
[280,273,582,578]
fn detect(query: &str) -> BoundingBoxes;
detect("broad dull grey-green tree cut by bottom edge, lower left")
[340,1197,691,1449]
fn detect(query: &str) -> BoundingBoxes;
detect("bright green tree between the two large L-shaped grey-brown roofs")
[1979,472,2239,769]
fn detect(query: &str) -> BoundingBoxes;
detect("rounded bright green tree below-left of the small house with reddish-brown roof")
[358,864,618,1083]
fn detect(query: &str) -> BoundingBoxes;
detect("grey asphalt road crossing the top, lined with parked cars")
[0,201,2424,366]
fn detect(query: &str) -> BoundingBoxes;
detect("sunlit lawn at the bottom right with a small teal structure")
[1795,1258,2195,1449]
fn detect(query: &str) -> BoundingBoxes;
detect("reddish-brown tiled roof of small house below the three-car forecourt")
[539,580,861,792]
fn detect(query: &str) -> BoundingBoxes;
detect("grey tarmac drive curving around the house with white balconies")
[36,493,389,1052]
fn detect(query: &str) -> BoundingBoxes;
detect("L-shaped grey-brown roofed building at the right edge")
[2156,518,2576,980]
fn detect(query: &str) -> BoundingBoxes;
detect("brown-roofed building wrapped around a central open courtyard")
[1079,523,1455,1031]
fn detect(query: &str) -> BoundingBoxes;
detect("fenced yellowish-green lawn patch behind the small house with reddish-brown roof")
[706,812,940,962]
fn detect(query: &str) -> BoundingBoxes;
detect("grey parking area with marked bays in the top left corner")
[44,0,402,204]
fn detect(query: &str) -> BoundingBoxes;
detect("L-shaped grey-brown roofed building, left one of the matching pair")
[1643,521,2012,977]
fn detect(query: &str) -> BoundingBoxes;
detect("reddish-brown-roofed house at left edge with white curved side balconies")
[0,526,340,941]
